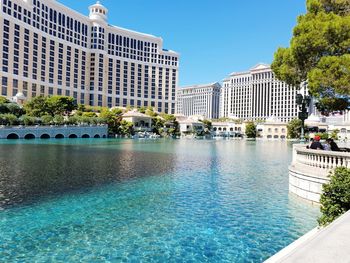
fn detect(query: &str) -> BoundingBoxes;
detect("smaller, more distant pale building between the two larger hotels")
[176,83,221,119]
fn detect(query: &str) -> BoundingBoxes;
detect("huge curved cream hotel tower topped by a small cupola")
[0,0,179,113]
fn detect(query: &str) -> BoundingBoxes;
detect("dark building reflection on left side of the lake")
[0,140,173,207]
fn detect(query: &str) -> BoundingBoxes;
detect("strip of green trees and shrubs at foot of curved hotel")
[0,96,179,137]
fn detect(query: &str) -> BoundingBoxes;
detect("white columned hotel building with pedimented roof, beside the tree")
[220,64,298,122]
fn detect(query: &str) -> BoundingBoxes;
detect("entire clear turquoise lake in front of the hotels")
[0,139,318,262]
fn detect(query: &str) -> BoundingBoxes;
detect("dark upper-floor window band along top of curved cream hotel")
[3,0,178,66]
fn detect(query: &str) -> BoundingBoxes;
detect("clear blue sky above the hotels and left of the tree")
[58,0,305,86]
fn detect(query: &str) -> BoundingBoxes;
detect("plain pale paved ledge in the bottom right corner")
[265,211,350,263]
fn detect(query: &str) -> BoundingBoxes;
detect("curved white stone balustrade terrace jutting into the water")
[289,144,350,203]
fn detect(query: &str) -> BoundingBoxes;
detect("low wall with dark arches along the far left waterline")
[0,125,108,139]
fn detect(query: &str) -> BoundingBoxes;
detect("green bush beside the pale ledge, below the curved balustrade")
[318,167,350,226]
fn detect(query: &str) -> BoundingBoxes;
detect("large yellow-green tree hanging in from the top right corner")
[271,0,350,111]
